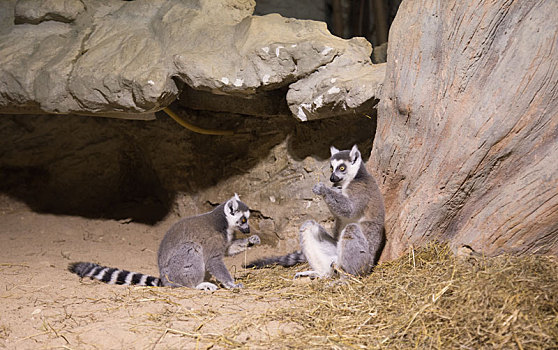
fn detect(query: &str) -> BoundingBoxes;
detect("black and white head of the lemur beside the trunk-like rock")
[329,145,362,188]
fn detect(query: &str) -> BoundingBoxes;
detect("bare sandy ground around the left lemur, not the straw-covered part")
[0,200,300,349]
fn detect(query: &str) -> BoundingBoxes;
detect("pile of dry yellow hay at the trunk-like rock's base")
[234,244,558,349]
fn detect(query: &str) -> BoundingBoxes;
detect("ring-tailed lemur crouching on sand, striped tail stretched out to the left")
[68,194,260,290]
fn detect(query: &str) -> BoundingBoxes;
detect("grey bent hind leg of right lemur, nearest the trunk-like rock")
[337,223,372,275]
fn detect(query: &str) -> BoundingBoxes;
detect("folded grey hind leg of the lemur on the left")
[159,242,209,290]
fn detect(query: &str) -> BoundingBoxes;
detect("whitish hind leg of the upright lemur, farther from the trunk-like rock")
[295,220,337,278]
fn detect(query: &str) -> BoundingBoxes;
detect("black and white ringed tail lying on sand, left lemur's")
[68,262,162,287]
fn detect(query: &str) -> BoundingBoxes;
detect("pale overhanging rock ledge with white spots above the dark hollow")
[0,0,383,120]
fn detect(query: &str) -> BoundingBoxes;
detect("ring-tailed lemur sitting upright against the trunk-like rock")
[247,145,385,277]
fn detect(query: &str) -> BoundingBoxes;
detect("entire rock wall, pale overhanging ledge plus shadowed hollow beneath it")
[0,0,385,250]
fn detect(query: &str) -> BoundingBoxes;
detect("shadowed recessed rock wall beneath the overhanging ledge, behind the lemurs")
[0,109,375,251]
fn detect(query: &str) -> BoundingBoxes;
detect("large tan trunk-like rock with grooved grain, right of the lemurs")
[368,0,558,259]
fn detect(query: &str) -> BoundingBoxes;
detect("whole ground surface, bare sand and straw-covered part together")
[0,196,558,350]
